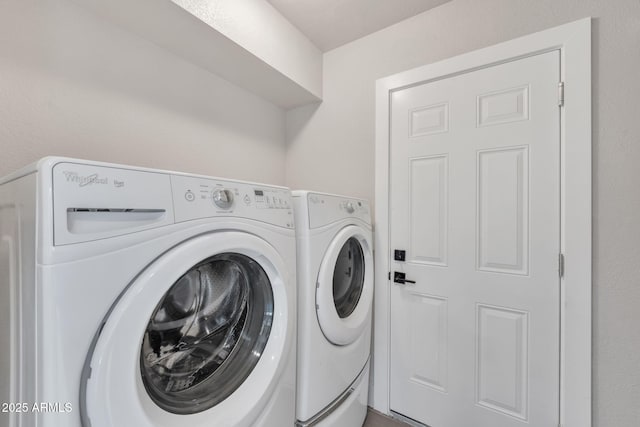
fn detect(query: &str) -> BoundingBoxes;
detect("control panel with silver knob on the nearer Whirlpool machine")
[171,175,294,228]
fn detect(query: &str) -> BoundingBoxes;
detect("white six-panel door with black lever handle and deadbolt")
[390,51,560,427]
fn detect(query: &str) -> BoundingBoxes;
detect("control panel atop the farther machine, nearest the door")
[307,193,371,228]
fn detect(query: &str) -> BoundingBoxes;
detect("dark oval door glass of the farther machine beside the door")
[333,237,364,319]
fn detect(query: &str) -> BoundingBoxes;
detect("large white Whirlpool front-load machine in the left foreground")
[0,158,296,427]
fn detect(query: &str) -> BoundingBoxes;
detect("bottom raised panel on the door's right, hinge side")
[476,304,528,420]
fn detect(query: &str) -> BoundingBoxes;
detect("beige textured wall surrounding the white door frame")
[286,0,640,427]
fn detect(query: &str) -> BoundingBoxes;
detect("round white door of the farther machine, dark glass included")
[316,225,373,345]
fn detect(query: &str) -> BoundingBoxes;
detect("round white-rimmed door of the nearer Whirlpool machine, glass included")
[81,231,293,427]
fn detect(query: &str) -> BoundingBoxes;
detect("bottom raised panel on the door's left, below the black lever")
[408,294,447,392]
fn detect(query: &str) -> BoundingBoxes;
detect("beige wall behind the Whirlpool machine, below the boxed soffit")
[0,0,285,184]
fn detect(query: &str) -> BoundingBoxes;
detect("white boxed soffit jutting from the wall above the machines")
[78,0,322,109]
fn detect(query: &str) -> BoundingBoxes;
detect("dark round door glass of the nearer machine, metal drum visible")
[140,253,273,414]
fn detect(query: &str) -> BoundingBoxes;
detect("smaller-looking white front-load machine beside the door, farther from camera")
[293,191,373,427]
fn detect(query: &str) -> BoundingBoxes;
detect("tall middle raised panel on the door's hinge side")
[477,147,529,275]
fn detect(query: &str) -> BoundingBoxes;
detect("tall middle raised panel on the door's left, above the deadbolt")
[409,155,448,265]
